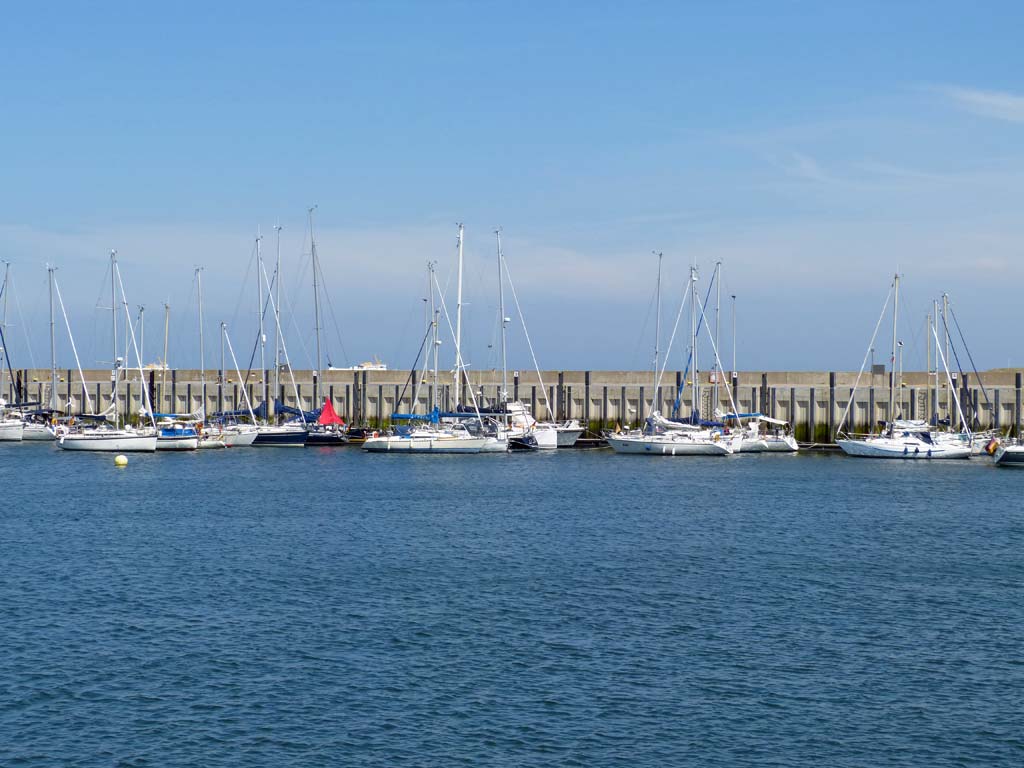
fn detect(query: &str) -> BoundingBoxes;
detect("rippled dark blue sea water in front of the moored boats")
[0,444,1024,767]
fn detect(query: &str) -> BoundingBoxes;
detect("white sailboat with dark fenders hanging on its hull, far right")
[836,273,974,460]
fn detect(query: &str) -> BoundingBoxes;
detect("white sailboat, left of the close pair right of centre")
[604,262,742,456]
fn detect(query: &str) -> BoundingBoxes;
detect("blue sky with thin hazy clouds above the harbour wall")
[0,0,1024,371]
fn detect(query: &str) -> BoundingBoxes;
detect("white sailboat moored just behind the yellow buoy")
[57,251,157,453]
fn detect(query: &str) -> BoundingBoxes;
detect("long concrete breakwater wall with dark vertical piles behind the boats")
[4,369,1024,442]
